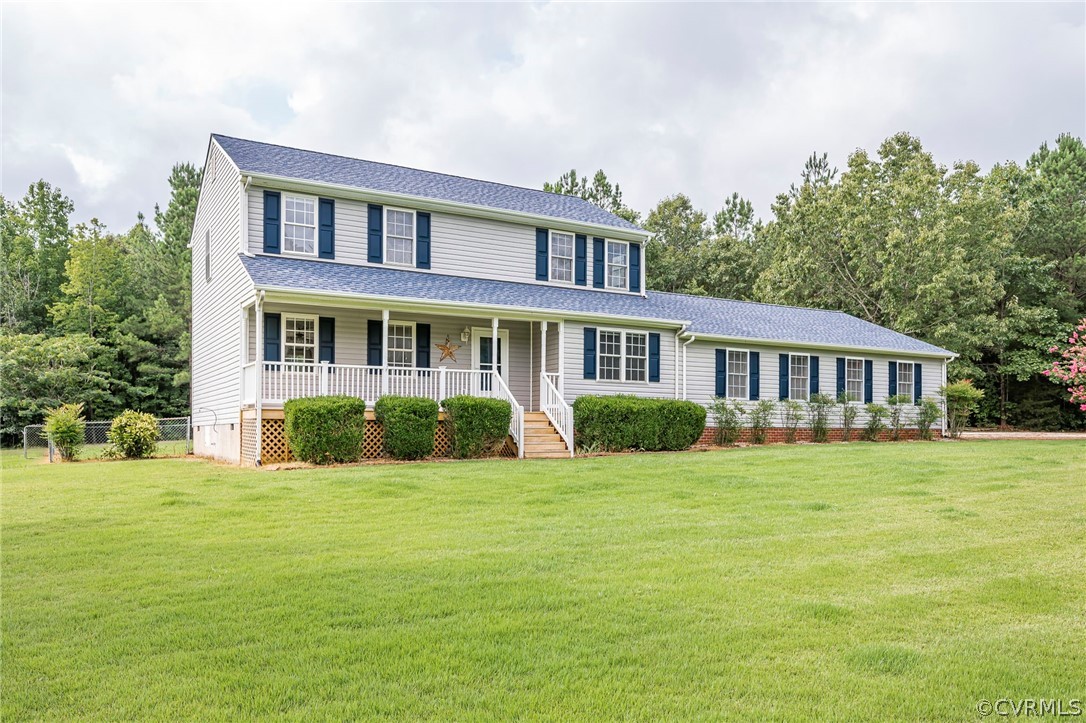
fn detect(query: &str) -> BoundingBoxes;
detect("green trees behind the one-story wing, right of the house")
[544,132,1086,429]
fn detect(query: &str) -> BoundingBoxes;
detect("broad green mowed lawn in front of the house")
[0,442,1086,720]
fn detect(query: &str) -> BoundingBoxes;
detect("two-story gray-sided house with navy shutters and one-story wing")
[191,135,954,464]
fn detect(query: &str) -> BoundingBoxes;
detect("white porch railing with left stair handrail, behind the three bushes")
[250,362,525,456]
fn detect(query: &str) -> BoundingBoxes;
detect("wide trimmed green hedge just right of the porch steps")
[573,394,705,452]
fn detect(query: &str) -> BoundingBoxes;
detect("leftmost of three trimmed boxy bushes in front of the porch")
[282,396,366,465]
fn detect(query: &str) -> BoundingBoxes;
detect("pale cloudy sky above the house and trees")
[2,2,1086,230]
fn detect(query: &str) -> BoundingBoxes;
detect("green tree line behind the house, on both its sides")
[0,134,1086,444]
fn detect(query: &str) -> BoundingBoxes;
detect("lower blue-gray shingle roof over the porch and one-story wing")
[241,255,950,356]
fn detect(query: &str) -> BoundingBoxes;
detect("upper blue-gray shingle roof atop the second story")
[212,134,641,230]
